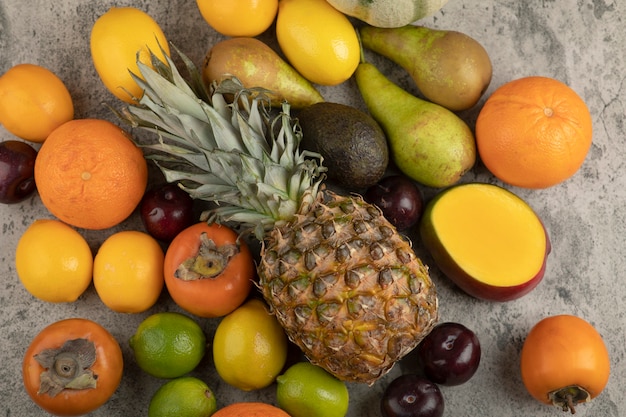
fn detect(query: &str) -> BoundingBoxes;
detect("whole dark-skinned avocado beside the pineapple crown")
[296,102,389,189]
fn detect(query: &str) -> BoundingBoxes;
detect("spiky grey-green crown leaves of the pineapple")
[116,44,326,240]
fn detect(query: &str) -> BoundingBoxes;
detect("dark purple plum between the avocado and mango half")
[363,175,424,230]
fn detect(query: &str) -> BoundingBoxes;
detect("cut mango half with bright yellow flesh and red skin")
[419,183,551,301]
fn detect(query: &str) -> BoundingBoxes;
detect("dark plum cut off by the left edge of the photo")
[0,140,37,204]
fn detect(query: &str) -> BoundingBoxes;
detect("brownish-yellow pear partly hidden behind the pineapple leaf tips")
[202,37,324,109]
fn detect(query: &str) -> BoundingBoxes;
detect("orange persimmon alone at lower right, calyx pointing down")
[520,314,611,414]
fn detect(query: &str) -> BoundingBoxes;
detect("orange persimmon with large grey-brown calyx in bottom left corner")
[22,318,124,416]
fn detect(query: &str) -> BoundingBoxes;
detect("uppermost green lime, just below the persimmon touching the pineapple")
[129,312,206,378]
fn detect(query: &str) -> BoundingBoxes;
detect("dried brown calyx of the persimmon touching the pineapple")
[175,232,239,281]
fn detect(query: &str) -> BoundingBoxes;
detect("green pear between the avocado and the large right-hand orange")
[355,62,476,188]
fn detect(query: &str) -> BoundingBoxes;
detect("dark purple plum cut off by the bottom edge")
[380,374,444,417]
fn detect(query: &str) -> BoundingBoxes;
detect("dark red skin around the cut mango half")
[419,187,552,302]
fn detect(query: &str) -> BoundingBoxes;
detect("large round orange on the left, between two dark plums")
[35,119,148,230]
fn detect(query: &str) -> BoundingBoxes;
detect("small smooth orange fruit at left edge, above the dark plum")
[0,64,74,142]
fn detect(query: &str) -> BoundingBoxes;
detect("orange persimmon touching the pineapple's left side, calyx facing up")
[164,222,255,318]
